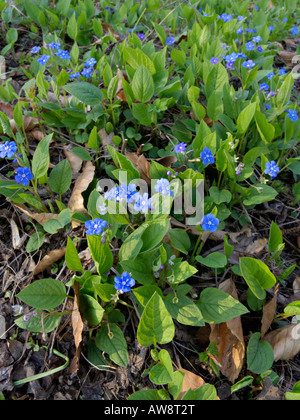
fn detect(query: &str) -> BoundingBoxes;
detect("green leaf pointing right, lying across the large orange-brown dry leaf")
[197,287,248,324]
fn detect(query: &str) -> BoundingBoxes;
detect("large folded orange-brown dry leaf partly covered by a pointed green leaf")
[210,279,245,383]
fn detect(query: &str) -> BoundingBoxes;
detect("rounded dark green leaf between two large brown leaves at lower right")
[247,332,274,375]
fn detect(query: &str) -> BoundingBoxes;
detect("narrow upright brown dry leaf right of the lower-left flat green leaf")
[69,281,83,373]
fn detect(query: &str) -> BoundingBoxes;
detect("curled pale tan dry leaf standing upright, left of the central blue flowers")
[68,162,95,228]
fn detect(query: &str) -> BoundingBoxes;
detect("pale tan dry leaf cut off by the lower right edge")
[264,324,300,362]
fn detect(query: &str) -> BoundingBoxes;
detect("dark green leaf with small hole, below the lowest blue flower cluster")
[95,324,128,367]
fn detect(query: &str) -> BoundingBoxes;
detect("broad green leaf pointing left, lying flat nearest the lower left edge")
[17,279,67,310]
